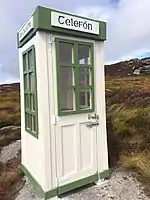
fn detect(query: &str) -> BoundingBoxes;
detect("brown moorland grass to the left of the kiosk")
[0,85,24,200]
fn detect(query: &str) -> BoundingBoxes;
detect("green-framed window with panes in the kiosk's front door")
[56,39,94,115]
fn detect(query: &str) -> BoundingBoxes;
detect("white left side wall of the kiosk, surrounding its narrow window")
[19,36,49,190]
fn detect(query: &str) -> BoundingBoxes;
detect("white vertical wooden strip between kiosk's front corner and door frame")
[36,32,57,191]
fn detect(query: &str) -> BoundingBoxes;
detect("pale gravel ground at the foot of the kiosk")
[15,170,150,200]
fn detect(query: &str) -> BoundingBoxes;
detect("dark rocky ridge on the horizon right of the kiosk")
[105,57,150,77]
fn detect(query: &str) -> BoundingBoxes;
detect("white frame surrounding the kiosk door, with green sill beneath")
[48,34,109,195]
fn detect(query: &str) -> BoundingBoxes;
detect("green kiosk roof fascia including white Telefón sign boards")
[17,6,106,47]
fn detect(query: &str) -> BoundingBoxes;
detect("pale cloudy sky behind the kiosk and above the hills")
[0,0,150,83]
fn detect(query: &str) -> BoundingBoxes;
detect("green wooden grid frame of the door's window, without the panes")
[55,38,95,116]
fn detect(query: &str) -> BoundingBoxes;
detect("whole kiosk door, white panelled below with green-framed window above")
[52,39,99,193]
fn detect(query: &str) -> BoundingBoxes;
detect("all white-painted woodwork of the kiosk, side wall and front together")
[19,32,108,196]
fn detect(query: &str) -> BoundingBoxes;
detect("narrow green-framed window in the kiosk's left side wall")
[22,45,38,138]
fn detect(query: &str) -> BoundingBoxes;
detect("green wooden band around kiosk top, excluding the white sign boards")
[17,6,106,48]
